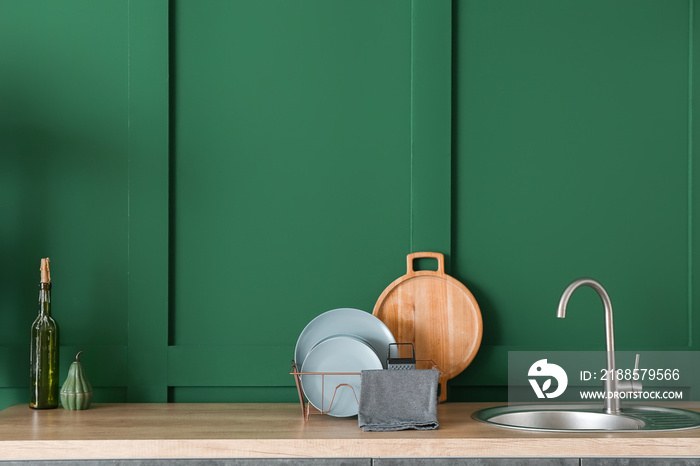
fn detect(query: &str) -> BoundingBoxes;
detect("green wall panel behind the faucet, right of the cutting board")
[452,0,697,394]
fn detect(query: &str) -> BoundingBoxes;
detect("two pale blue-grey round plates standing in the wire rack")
[294,308,396,417]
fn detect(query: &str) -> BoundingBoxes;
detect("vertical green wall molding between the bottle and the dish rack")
[127,0,169,402]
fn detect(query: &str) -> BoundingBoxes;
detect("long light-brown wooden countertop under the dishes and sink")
[0,403,700,459]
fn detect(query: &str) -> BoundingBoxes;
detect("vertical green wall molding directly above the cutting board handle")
[410,0,452,264]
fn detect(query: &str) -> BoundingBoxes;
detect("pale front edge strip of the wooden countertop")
[0,437,700,460]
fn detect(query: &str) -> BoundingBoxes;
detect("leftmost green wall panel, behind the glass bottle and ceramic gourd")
[0,1,134,407]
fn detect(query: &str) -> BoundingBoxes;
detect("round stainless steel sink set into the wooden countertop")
[472,404,700,432]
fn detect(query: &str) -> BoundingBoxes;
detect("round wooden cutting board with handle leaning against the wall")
[372,252,483,401]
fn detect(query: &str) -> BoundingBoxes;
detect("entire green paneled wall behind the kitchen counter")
[0,0,700,408]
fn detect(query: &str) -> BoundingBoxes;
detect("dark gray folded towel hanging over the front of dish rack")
[357,369,440,432]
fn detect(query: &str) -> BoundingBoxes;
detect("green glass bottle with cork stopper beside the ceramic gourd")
[29,257,58,409]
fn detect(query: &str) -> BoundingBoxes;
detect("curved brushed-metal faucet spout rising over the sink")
[557,278,620,414]
